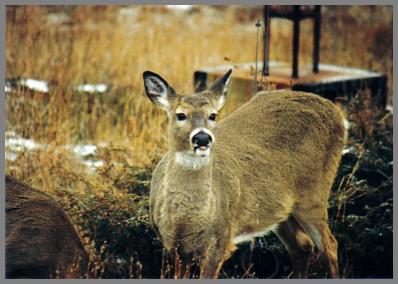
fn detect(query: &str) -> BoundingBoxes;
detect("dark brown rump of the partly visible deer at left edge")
[5,176,89,279]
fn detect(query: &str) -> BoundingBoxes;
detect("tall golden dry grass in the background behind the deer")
[6,5,392,178]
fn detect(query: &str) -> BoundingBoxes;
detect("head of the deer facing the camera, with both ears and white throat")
[143,70,232,169]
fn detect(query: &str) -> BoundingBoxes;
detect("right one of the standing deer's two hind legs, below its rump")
[299,217,339,278]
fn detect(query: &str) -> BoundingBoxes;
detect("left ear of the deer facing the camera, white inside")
[142,71,176,111]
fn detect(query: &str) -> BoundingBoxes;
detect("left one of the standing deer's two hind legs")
[275,216,314,278]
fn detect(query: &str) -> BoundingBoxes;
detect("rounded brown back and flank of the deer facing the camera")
[214,90,345,231]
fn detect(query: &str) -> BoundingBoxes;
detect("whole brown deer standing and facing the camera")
[143,69,346,278]
